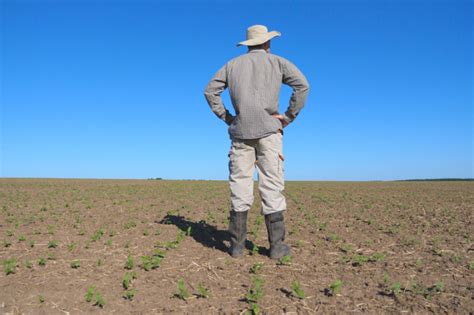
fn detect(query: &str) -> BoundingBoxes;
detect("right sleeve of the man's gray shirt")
[282,58,309,123]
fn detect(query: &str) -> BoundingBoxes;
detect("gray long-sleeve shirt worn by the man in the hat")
[204,49,309,139]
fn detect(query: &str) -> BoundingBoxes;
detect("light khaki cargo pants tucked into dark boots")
[229,132,286,215]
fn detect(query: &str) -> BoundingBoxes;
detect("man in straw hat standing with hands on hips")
[204,25,309,259]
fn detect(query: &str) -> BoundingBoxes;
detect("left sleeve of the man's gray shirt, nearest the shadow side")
[204,65,235,125]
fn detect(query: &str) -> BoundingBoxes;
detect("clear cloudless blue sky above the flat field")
[0,0,474,180]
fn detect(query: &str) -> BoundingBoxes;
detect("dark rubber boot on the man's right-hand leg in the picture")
[265,211,290,259]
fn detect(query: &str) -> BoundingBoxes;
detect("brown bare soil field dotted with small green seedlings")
[0,179,474,314]
